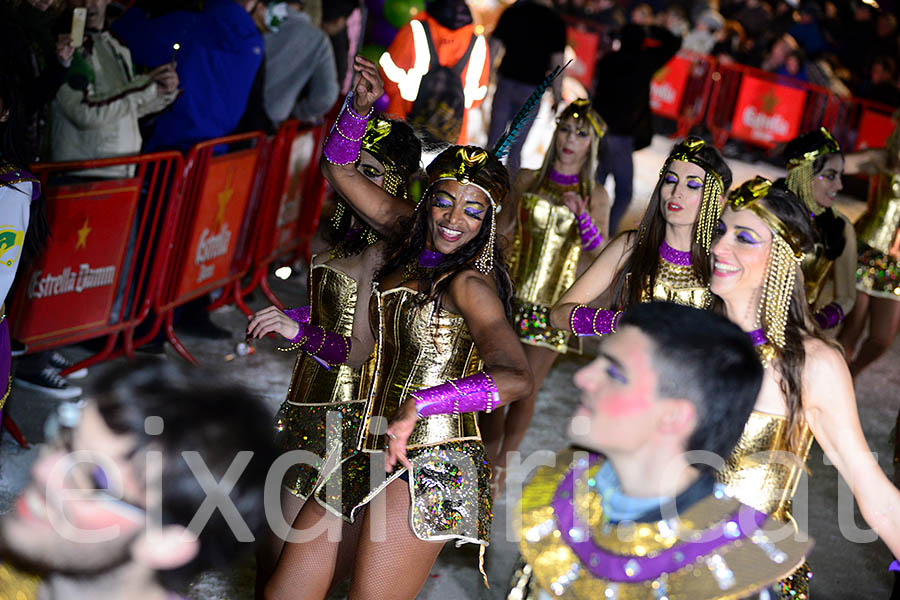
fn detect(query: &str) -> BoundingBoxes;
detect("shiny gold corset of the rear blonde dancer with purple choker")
[511,181,581,306]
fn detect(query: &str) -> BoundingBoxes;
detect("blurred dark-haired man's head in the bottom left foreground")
[0,363,276,600]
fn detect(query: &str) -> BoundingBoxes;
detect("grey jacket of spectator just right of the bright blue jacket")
[263,2,339,127]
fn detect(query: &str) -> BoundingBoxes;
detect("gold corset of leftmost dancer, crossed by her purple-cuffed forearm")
[288,264,359,404]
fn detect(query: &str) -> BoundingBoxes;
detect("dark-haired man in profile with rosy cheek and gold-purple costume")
[508,302,811,600]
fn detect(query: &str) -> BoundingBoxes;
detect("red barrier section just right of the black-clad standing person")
[650,50,715,137]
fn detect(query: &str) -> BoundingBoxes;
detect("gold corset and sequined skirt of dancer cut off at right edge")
[856,173,900,300]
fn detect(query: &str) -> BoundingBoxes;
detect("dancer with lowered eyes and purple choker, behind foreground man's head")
[550,137,731,336]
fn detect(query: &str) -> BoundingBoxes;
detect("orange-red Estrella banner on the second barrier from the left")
[176,150,259,298]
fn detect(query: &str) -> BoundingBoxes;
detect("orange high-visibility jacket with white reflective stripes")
[378,0,490,144]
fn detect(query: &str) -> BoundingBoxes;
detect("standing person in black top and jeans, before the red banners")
[593,14,681,235]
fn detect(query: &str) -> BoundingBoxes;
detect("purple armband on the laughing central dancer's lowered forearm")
[411,371,500,418]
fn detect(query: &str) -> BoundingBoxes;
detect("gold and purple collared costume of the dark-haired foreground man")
[508,450,810,600]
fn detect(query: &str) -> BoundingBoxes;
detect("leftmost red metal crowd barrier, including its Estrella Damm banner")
[10,152,184,372]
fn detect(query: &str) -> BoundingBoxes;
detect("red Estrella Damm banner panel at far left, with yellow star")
[12,178,141,344]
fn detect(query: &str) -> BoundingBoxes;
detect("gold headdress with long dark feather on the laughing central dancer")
[416,65,568,275]
